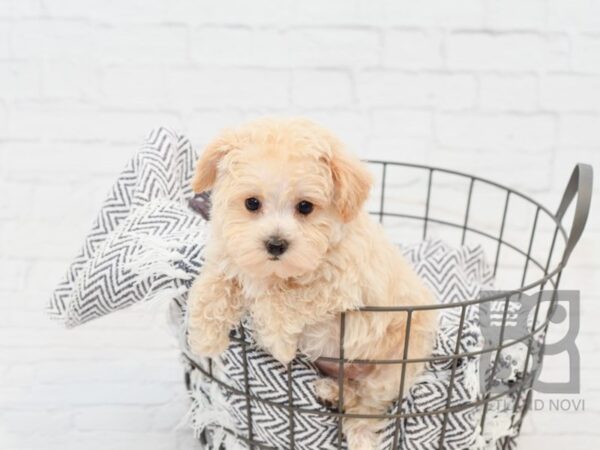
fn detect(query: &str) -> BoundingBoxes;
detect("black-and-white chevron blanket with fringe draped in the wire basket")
[48,128,521,450]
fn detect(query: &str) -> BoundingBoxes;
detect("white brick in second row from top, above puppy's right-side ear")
[289,28,381,67]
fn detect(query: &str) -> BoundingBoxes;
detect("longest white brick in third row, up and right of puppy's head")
[357,70,477,109]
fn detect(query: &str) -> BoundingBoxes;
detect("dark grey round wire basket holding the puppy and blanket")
[186,161,593,450]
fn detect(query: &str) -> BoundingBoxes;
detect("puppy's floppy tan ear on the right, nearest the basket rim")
[330,143,373,222]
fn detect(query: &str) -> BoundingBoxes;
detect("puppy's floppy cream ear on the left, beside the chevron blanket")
[192,130,238,193]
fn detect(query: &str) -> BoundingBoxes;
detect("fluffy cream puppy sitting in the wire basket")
[188,119,437,450]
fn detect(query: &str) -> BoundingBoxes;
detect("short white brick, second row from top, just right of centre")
[383,30,443,69]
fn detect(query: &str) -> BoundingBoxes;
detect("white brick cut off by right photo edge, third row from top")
[540,75,600,111]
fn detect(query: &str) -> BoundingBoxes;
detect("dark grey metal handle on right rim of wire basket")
[556,163,594,266]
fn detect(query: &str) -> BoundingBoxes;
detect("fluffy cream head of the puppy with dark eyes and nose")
[193,119,371,278]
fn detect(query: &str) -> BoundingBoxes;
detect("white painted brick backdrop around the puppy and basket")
[0,0,600,450]
